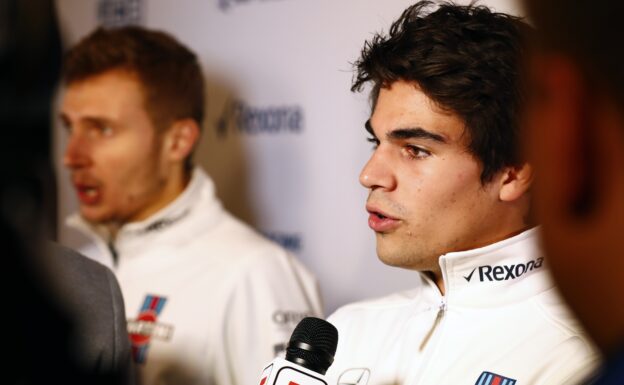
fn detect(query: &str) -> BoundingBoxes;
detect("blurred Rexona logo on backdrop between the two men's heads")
[217,100,305,138]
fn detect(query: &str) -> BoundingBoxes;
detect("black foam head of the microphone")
[286,317,338,374]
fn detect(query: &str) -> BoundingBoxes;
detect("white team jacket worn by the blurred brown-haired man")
[68,169,322,385]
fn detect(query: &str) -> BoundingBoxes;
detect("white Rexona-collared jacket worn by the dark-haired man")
[327,229,598,385]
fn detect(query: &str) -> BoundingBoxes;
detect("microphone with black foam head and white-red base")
[260,317,338,385]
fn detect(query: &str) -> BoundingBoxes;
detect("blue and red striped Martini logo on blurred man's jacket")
[128,294,173,364]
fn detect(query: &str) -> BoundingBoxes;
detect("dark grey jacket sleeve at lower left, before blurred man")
[47,243,134,384]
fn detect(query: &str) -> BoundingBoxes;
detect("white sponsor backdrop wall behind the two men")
[56,0,519,313]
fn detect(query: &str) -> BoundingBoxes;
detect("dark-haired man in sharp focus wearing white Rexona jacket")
[328,2,598,385]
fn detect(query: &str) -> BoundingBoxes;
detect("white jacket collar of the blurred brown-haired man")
[66,167,223,255]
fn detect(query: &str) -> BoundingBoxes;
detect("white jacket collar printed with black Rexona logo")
[421,228,554,307]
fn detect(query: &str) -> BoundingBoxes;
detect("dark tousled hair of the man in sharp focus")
[351,1,531,183]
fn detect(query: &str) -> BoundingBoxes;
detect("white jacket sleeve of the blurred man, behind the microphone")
[215,248,322,385]
